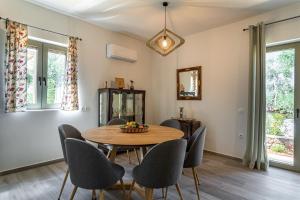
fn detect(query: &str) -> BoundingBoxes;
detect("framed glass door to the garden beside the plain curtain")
[266,43,300,170]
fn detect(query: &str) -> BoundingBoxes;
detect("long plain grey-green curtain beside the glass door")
[244,23,269,170]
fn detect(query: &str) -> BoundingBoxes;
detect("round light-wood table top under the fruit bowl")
[82,125,184,146]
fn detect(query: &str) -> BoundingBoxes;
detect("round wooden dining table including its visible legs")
[82,125,184,196]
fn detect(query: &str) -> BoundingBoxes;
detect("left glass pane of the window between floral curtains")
[27,47,38,105]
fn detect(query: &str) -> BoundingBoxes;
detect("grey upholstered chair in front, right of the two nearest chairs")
[129,139,187,199]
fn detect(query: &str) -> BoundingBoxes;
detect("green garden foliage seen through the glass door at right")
[266,49,295,135]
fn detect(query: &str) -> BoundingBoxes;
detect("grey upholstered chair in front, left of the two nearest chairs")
[65,139,125,200]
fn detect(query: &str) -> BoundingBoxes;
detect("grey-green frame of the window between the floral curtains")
[27,39,67,110]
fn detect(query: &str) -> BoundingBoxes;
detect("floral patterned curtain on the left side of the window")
[5,20,28,112]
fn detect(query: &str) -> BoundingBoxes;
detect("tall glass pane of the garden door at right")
[266,49,295,165]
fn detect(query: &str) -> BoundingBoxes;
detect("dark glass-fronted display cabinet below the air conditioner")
[98,88,146,126]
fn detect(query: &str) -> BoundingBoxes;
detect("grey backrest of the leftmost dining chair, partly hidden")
[58,124,84,163]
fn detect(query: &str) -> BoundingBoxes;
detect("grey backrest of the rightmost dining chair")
[184,126,206,168]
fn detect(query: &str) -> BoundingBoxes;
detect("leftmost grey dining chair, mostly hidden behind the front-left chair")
[58,124,84,199]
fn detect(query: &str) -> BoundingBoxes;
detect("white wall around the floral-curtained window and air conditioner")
[0,0,152,171]
